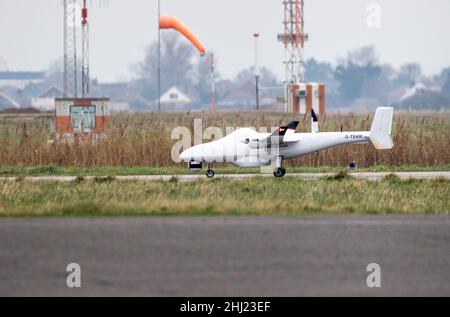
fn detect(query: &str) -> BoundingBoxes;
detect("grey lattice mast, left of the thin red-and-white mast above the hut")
[63,0,78,98]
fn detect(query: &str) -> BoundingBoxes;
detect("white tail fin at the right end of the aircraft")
[370,107,394,150]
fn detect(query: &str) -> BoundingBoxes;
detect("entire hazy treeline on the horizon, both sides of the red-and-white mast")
[39,33,450,111]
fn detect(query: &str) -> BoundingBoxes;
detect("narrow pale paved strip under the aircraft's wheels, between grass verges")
[0,172,450,182]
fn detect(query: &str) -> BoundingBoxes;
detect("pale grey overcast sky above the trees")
[0,0,450,82]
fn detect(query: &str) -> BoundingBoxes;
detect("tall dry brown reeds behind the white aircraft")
[0,112,450,168]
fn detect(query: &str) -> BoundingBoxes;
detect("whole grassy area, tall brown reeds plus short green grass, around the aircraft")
[0,112,450,217]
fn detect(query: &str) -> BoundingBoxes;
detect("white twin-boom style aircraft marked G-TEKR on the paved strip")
[180,108,394,178]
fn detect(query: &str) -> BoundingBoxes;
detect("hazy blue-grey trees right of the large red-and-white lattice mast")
[306,46,450,110]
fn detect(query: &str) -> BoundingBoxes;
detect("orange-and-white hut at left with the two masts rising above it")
[54,0,110,144]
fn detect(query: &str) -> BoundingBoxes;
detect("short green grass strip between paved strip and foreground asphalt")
[0,175,450,217]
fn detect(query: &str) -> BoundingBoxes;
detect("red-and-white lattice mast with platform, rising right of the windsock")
[278,0,308,83]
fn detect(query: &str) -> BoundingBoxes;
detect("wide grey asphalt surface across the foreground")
[0,216,450,296]
